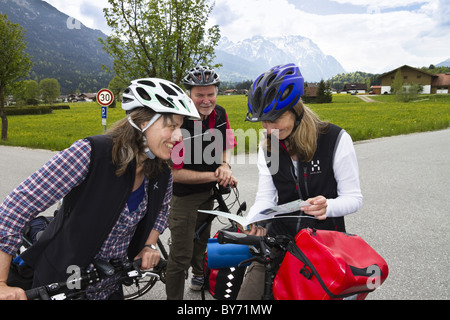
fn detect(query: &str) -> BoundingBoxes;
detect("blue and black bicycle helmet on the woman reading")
[246,63,305,122]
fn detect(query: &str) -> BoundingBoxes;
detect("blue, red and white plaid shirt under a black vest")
[0,139,172,299]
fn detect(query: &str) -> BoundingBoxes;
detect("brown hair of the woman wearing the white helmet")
[106,108,172,178]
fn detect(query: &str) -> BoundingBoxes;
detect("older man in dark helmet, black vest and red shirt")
[166,66,237,300]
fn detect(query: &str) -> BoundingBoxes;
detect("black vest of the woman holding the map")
[266,124,345,236]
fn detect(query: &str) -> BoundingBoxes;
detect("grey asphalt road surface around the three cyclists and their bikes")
[0,129,450,300]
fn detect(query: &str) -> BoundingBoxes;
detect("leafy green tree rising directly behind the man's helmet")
[100,0,220,84]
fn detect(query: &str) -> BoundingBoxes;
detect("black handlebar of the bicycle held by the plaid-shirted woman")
[25,259,166,300]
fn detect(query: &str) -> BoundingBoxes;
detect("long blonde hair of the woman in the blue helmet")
[266,99,329,162]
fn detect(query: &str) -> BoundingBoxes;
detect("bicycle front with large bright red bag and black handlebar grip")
[217,228,389,300]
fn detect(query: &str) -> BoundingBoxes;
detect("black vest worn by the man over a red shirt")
[173,105,227,196]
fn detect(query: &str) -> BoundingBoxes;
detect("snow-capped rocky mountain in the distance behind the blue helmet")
[215,36,345,82]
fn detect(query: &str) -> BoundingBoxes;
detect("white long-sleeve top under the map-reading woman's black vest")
[248,131,363,218]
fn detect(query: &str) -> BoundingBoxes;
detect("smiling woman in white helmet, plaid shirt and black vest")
[0,79,199,299]
